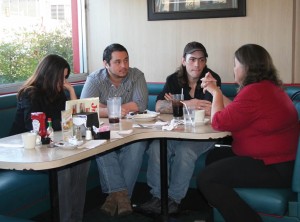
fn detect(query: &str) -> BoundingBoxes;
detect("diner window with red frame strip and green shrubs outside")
[0,0,87,95]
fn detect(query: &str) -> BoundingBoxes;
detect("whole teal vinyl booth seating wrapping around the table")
[0,83,300,222]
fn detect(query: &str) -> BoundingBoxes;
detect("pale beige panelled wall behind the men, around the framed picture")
[87,0,300,84]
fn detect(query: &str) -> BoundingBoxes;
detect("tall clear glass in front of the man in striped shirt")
[107,97,122,124]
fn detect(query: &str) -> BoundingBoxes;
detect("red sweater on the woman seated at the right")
[212,81,299,164]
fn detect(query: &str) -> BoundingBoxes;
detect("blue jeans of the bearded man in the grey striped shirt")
[96,141,147,197]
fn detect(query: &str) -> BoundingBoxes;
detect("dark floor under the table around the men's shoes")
[34,183,211,222]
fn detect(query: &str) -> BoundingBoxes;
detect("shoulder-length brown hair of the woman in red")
[234,44,282,90]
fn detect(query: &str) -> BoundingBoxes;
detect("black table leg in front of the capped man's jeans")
[160,138,169,222]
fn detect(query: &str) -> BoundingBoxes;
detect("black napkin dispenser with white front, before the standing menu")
[72,112,99,136]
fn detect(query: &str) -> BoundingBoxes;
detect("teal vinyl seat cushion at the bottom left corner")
[0,170,50,218]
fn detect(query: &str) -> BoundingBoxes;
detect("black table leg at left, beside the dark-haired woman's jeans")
[49,169,60,222]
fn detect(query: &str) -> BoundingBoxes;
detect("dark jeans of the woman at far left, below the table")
[57,160,91,222]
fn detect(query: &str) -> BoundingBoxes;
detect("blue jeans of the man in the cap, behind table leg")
[147,140,215,203]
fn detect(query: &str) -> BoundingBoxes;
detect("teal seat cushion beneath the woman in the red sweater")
[236,188,296,216]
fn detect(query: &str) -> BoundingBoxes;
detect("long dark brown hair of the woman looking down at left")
[17,54,71,102]
